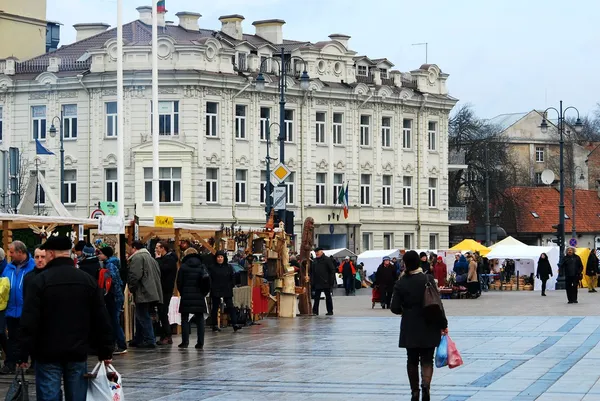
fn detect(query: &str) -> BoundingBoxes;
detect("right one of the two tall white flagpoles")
[152,0,160,216]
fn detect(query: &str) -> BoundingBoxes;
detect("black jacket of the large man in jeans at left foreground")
[19,257,114,363]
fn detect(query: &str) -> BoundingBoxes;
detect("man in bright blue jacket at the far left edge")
[0,241,35,375]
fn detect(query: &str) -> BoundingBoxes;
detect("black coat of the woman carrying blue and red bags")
[390,273,448,348]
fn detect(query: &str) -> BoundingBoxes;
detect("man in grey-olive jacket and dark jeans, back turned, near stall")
[127,241,163,348]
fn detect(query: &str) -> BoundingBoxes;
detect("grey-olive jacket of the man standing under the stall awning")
[127,248,163,304]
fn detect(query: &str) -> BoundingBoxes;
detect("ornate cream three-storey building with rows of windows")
[0,7,457,252]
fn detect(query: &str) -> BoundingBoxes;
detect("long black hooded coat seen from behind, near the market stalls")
[177,254,210,315]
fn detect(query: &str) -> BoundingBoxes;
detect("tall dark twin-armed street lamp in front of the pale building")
[256,47,310,229]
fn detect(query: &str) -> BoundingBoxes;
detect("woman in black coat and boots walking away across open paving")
[391,251,448,401]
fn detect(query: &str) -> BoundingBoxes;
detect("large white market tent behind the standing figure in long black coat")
[486,244,560,290]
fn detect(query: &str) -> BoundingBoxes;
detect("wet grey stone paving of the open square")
[0,290,600,401]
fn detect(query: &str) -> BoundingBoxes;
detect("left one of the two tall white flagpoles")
[116,0,125,219]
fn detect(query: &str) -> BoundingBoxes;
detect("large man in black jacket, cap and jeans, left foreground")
[19,236,113,401]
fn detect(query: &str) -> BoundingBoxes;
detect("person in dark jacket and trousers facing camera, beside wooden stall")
[209,251,242,332]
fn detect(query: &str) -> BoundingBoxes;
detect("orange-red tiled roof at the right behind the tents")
[508,187,600,234]
